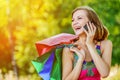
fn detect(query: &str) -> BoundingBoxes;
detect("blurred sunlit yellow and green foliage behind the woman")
[0,0,120,80]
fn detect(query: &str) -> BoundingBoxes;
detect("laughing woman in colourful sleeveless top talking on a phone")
[62,6,112,80]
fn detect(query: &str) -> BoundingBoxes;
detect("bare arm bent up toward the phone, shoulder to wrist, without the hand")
[87,40,112,77]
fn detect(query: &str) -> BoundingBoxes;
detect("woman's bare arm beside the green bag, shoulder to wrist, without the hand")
[62,47,83,80]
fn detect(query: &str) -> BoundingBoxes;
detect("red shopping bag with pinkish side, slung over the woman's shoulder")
[36,33,77,56]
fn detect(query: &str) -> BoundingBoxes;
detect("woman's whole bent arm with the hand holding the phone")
[84,22,112,77]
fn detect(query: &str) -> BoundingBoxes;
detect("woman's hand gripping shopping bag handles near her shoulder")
[70,47,85,61]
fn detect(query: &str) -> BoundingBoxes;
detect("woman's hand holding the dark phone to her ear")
[84,22,96,44]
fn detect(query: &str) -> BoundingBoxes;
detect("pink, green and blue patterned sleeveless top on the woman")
[73,45,102,80]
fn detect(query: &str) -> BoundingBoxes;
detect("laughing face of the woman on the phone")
[72,10,89,35]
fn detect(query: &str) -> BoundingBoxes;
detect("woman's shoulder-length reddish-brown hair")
[72,6,109,41]
